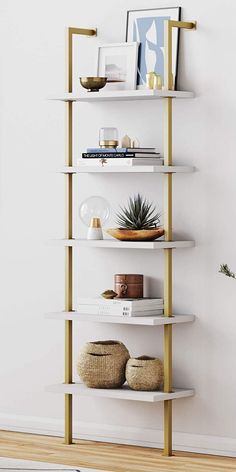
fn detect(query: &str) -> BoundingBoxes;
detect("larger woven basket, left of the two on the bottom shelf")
[77,341,130,388]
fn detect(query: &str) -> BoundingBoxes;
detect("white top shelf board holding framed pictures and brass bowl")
[49,89,194,102]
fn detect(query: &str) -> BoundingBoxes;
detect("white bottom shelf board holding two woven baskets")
[46,383,194,403]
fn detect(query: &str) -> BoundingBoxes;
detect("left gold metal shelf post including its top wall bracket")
[65,28,97,444]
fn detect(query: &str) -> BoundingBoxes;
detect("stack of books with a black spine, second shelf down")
[79,148,163,170]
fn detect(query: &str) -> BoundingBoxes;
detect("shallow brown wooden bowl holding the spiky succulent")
[106,228,164,241]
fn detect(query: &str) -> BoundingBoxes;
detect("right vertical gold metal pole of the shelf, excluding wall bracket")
[164,21,172,456]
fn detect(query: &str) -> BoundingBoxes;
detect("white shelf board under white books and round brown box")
[45,311,195,326]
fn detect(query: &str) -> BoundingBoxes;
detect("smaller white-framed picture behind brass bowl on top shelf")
[97,41,139,90]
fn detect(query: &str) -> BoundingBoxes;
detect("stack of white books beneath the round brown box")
[77,298,164,316]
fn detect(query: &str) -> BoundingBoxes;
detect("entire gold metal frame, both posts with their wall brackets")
[62,20,196,456]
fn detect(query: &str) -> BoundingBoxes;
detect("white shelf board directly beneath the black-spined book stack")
[60,165,195,174]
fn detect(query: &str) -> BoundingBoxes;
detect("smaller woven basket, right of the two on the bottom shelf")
[125,356,164,391]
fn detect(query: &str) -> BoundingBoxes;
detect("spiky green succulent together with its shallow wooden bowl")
[106,194,164,241]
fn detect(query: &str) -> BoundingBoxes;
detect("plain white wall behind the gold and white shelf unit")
[0,0,236,454]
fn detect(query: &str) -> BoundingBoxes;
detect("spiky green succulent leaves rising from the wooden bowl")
[116,194,160,230]
